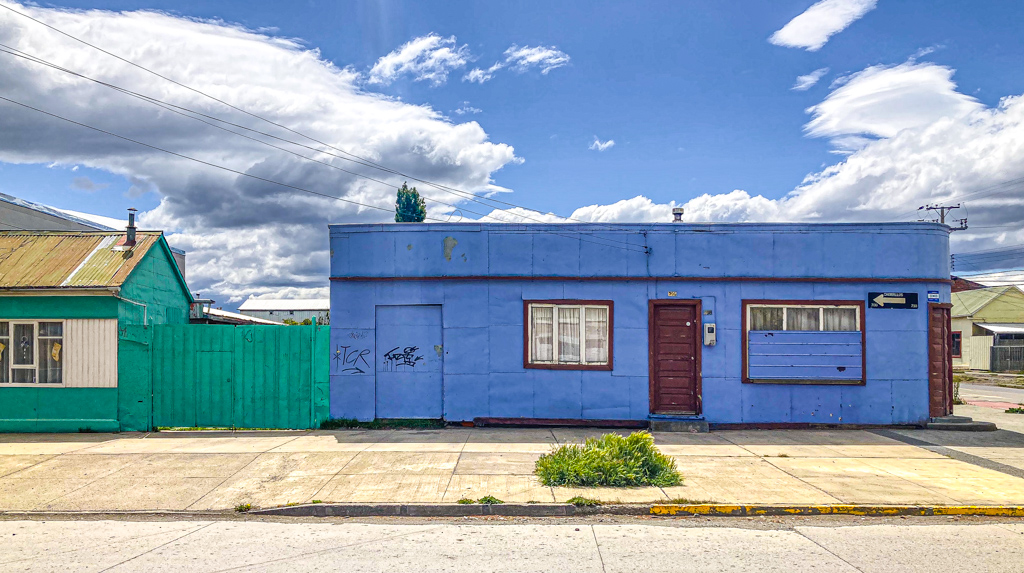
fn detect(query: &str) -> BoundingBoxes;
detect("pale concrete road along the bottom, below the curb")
[6,518,1024,573]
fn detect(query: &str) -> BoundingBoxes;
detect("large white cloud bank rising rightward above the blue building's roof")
[557,64,1024,270]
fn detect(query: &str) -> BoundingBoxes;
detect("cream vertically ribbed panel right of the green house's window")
[63,318,118,388]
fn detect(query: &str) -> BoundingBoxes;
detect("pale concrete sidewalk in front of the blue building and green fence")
[0,428,1024,511]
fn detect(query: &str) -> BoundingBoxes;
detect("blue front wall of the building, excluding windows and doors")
[331,223,949,424]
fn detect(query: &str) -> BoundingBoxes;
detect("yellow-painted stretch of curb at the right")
[650,503,1024,518]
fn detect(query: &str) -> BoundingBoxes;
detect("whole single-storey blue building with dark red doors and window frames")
[331,223,952,425]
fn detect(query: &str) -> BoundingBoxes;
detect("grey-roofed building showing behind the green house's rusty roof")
[0,193,185,276]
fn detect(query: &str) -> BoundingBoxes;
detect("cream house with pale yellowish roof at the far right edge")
[950,285,1024,370]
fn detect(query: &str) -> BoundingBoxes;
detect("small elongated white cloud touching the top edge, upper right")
[768,0,878,52]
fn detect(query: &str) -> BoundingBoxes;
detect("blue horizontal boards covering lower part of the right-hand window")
[748,330,862,381]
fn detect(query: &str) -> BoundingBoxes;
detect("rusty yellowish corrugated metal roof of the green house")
[0,231,162,289]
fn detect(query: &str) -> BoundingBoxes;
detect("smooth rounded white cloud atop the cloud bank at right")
[805,62,981,151]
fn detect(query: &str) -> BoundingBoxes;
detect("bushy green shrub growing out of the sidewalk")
[535,432,683,487]
